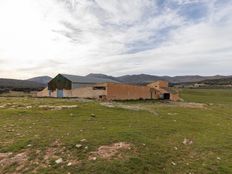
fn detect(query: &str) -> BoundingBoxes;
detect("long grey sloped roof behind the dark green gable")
[61,74,119,83]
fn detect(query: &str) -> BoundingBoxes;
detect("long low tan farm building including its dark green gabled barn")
[37,74,179,101]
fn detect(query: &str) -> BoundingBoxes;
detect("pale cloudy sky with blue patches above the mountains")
[0,0,232,78]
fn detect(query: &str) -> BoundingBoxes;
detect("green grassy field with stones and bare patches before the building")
[0,89,232,174]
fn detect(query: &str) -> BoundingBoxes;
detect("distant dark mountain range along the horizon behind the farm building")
[0,73,232,91]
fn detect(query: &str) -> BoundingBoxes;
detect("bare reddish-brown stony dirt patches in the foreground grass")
[0,140,132,174]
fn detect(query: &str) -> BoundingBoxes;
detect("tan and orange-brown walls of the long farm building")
[37,81,180,101]
